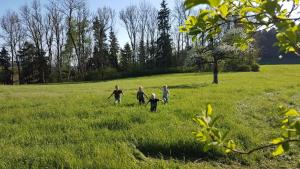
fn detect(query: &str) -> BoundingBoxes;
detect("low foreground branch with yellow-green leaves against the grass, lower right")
[193,104,300,156]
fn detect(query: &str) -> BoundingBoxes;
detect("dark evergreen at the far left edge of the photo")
[0,47,12,84]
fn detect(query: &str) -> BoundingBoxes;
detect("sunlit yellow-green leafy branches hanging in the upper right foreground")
[180,0,300,54]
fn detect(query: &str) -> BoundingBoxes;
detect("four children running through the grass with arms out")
[108,85,170,112]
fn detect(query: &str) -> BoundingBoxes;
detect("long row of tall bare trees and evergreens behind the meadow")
[0,0,199,84]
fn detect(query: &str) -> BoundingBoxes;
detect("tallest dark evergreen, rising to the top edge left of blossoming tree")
[156,0,172,67]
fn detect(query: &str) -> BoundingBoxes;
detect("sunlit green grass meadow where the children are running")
[0,65,300,169]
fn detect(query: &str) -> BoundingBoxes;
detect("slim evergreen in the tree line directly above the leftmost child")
[109,28,119,69]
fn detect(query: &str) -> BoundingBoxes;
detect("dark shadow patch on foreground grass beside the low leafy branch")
[136,141,226,162]
